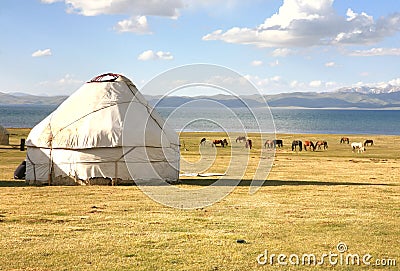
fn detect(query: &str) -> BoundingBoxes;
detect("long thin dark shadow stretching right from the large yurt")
[181,178,396,186]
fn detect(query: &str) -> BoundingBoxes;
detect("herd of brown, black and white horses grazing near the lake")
[200,136,374,153]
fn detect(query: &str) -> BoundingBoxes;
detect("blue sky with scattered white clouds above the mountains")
[0,0,400,96]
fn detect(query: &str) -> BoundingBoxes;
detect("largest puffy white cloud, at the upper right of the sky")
[203,0,400,47]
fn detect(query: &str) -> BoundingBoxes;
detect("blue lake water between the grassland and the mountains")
[0,105,400,135]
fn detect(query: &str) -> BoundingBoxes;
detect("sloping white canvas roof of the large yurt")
[27,74,179,149]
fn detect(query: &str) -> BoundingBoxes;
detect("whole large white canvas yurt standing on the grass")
[25,73,180,185]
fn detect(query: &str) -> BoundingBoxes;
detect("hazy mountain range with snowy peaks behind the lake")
[0,85,400,109]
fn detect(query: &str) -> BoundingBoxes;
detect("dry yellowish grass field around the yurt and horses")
[0,129,400,270]
